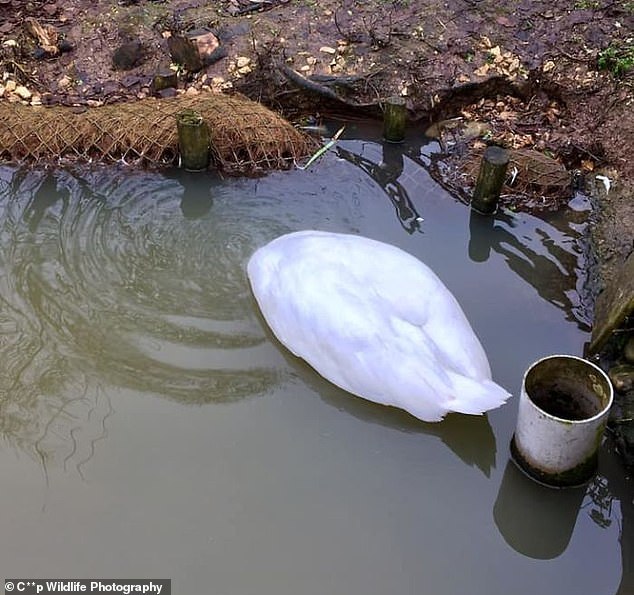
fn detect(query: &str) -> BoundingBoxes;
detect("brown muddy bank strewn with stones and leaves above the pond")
[0,0,634,286]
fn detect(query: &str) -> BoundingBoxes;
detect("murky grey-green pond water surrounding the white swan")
[0,127,634,595]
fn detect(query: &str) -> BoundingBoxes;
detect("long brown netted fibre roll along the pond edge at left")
[0,93,314,173]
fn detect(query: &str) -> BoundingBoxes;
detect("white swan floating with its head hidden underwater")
[247,231,510,421]
